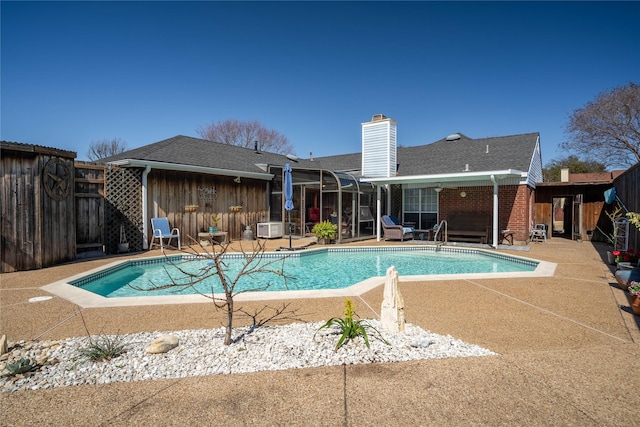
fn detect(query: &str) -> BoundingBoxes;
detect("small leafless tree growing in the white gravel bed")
[130,236,300,345]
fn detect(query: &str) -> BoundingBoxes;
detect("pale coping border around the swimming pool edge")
[40,246,557,308]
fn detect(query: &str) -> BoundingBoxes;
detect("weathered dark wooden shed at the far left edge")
[0,141,76,273]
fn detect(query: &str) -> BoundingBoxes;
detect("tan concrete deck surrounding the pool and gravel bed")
[0,238,640,426]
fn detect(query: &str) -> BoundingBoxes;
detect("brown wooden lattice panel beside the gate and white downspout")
[105,166,143,254]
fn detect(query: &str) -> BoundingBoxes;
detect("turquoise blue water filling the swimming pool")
[71,248,538,298]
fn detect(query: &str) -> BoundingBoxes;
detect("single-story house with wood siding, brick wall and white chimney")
[104,115,542,249]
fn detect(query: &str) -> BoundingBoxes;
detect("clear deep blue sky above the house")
[0,1,640,163]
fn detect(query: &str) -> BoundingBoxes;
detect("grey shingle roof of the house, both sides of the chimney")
[102,133,539,176]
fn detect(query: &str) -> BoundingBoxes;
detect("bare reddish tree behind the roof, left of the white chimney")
[198,119,293,154]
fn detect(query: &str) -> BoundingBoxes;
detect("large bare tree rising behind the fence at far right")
[561,83,640,168]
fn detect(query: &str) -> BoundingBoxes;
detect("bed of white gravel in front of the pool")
[0,320,495,392]
